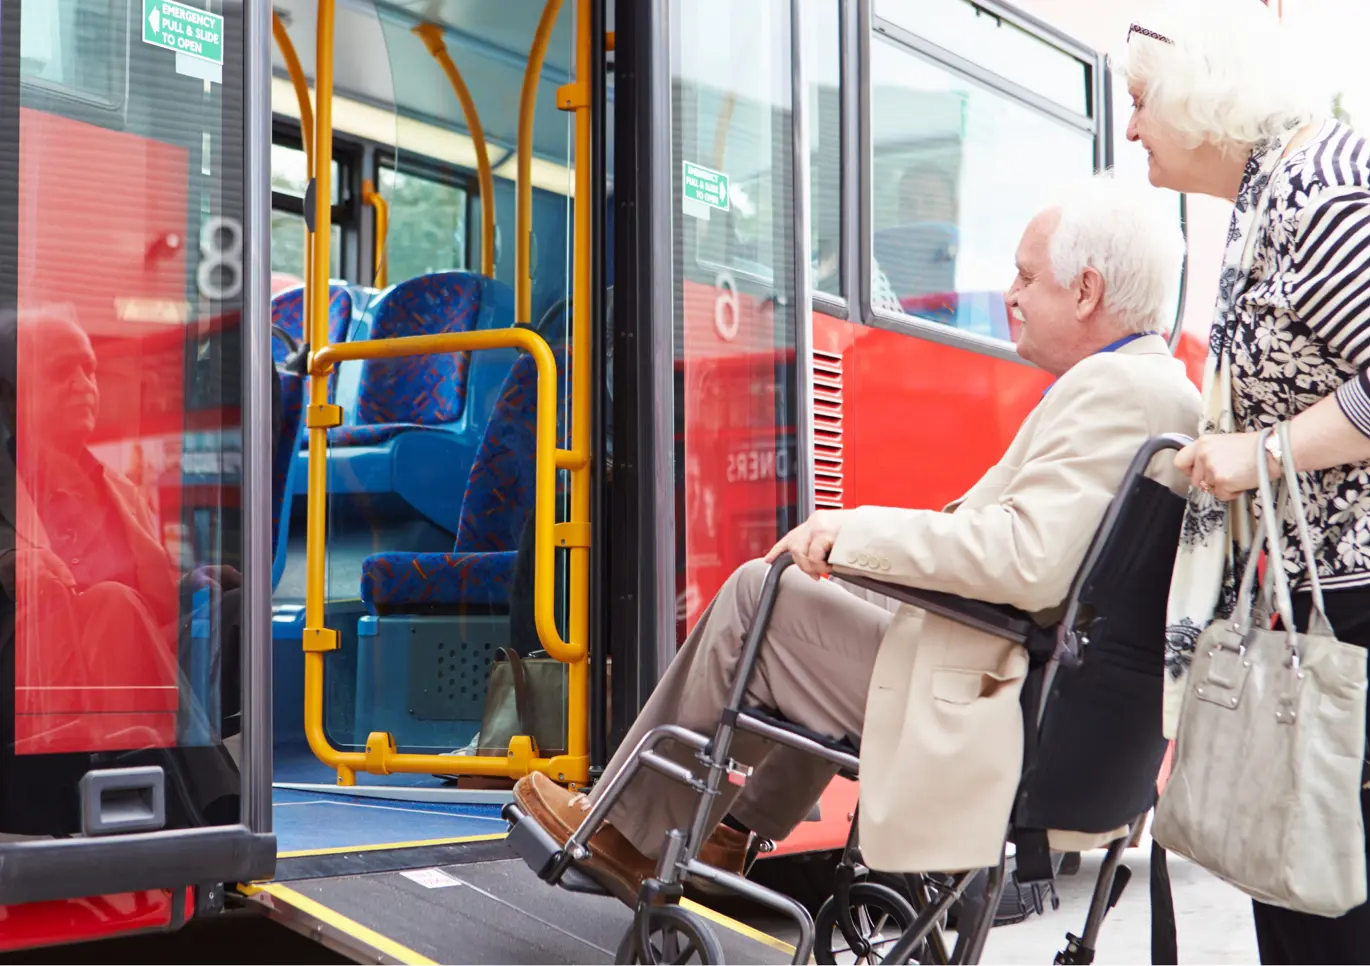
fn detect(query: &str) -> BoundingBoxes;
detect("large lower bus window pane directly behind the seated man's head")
[870,34,1095,340]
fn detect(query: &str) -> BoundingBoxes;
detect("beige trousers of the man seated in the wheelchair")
[590,560,892,856]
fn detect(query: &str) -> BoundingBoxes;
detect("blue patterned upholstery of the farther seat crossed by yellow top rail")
[347,271,493,445]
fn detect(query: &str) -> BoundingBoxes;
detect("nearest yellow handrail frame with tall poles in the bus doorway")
[303,0,593,785]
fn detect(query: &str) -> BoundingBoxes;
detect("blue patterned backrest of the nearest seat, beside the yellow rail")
[453,344,570,552]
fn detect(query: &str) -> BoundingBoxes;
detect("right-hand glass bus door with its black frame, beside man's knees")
[608,0,808,693]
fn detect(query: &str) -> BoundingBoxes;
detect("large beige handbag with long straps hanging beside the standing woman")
[1152,423,1366,917]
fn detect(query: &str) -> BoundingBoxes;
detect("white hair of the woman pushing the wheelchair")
[1126,0,1323,152]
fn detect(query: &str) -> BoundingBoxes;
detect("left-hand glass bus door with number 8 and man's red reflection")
[0,0,275,931]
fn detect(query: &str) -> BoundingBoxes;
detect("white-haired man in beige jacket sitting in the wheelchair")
[515,171,1199,903]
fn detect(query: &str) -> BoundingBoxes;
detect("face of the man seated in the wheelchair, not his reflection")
[1004,210,1081,375]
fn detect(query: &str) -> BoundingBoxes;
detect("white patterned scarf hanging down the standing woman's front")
[1162,122,1302,739]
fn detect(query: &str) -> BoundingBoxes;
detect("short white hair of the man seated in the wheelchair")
[1048,173,1185,333]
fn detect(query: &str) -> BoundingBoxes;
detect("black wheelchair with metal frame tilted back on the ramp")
[504,434,1189,963]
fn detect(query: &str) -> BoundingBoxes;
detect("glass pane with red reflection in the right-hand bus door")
[671,0,799,636]
